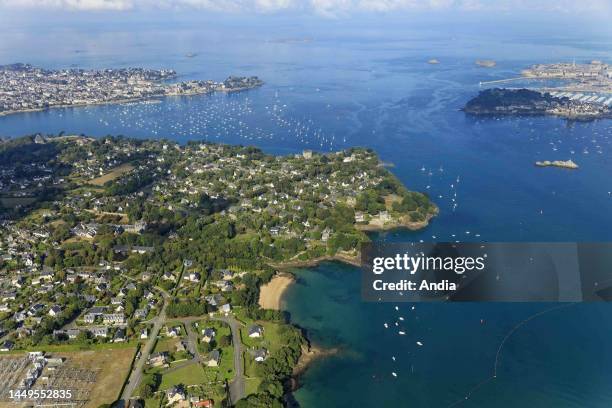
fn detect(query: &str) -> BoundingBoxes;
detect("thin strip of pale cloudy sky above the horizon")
[0,0,612,18]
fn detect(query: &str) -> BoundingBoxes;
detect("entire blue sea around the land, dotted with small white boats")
[0,12,612,407]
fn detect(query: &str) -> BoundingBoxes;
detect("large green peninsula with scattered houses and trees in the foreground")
[0,134,438,407]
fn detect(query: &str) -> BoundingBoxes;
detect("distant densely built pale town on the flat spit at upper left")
[0,63,263,115]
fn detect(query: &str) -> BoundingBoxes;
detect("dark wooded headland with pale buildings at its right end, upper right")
[463,88,612,120]
